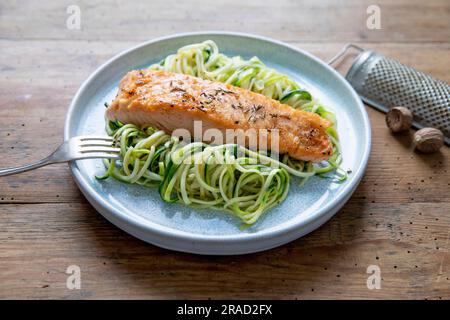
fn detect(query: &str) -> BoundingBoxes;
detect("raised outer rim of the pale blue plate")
[64,31,372,255]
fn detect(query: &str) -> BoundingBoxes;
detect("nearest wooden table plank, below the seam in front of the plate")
[0,202,450,299]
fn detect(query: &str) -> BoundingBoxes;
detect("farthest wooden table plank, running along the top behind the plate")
[0,0,450,42]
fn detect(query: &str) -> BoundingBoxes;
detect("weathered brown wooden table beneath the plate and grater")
[0,0,450,299]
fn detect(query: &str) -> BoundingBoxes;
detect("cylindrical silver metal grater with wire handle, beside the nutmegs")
[329,44,450,145]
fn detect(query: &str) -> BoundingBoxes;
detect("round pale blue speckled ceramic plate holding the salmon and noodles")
[64,32,371,255]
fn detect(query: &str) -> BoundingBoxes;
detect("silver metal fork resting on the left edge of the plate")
[0,136,120,177]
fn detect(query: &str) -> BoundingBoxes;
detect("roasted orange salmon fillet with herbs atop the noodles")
[106,70,333,162]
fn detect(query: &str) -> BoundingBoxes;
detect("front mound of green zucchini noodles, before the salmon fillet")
[97,121,300,225]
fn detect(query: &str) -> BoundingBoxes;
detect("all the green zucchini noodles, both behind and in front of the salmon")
[97,40,347,225]
